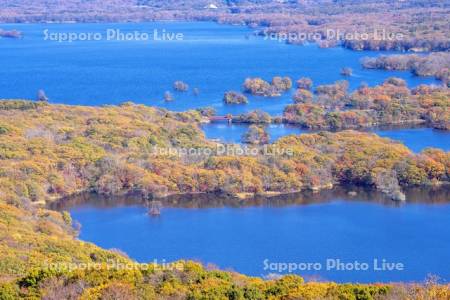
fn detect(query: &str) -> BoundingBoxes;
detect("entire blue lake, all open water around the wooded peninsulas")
[5,22,450,282]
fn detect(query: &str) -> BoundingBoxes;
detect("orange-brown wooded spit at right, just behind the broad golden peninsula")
[283,78,450,130]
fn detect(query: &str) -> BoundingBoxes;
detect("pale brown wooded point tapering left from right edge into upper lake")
[361,52,450,87]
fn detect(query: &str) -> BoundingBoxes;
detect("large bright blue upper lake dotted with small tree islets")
[0,22,436,114]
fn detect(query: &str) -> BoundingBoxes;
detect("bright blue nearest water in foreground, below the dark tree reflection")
[71,199,450,282]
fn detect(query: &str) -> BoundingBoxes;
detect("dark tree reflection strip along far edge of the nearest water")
[49,185,450,210]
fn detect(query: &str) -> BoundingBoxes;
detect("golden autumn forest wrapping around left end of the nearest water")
[0,100,450,299]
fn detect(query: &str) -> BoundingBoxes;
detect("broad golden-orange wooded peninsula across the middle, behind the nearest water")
[0,101,450,206]
